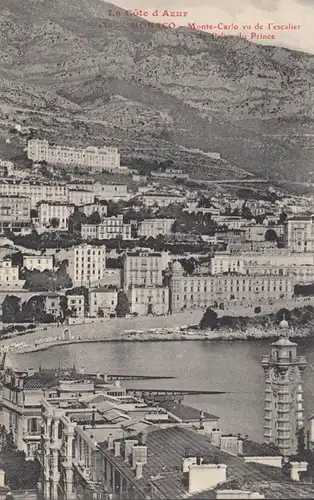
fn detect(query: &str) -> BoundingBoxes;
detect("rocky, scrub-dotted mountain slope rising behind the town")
[0,0,314,181]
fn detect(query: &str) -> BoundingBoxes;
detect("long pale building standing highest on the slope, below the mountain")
[27,139,120,171]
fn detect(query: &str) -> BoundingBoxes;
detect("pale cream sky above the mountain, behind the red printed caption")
[111,0,314,54]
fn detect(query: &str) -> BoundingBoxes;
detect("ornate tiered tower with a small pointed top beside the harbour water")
[262,319,306,456]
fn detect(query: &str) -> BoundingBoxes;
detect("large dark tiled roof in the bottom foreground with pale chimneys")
[100,427,314,500]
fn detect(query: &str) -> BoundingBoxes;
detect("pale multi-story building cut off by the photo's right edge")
[284,215,314,252]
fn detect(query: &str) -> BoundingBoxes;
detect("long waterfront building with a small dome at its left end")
[169,261,294,312]
